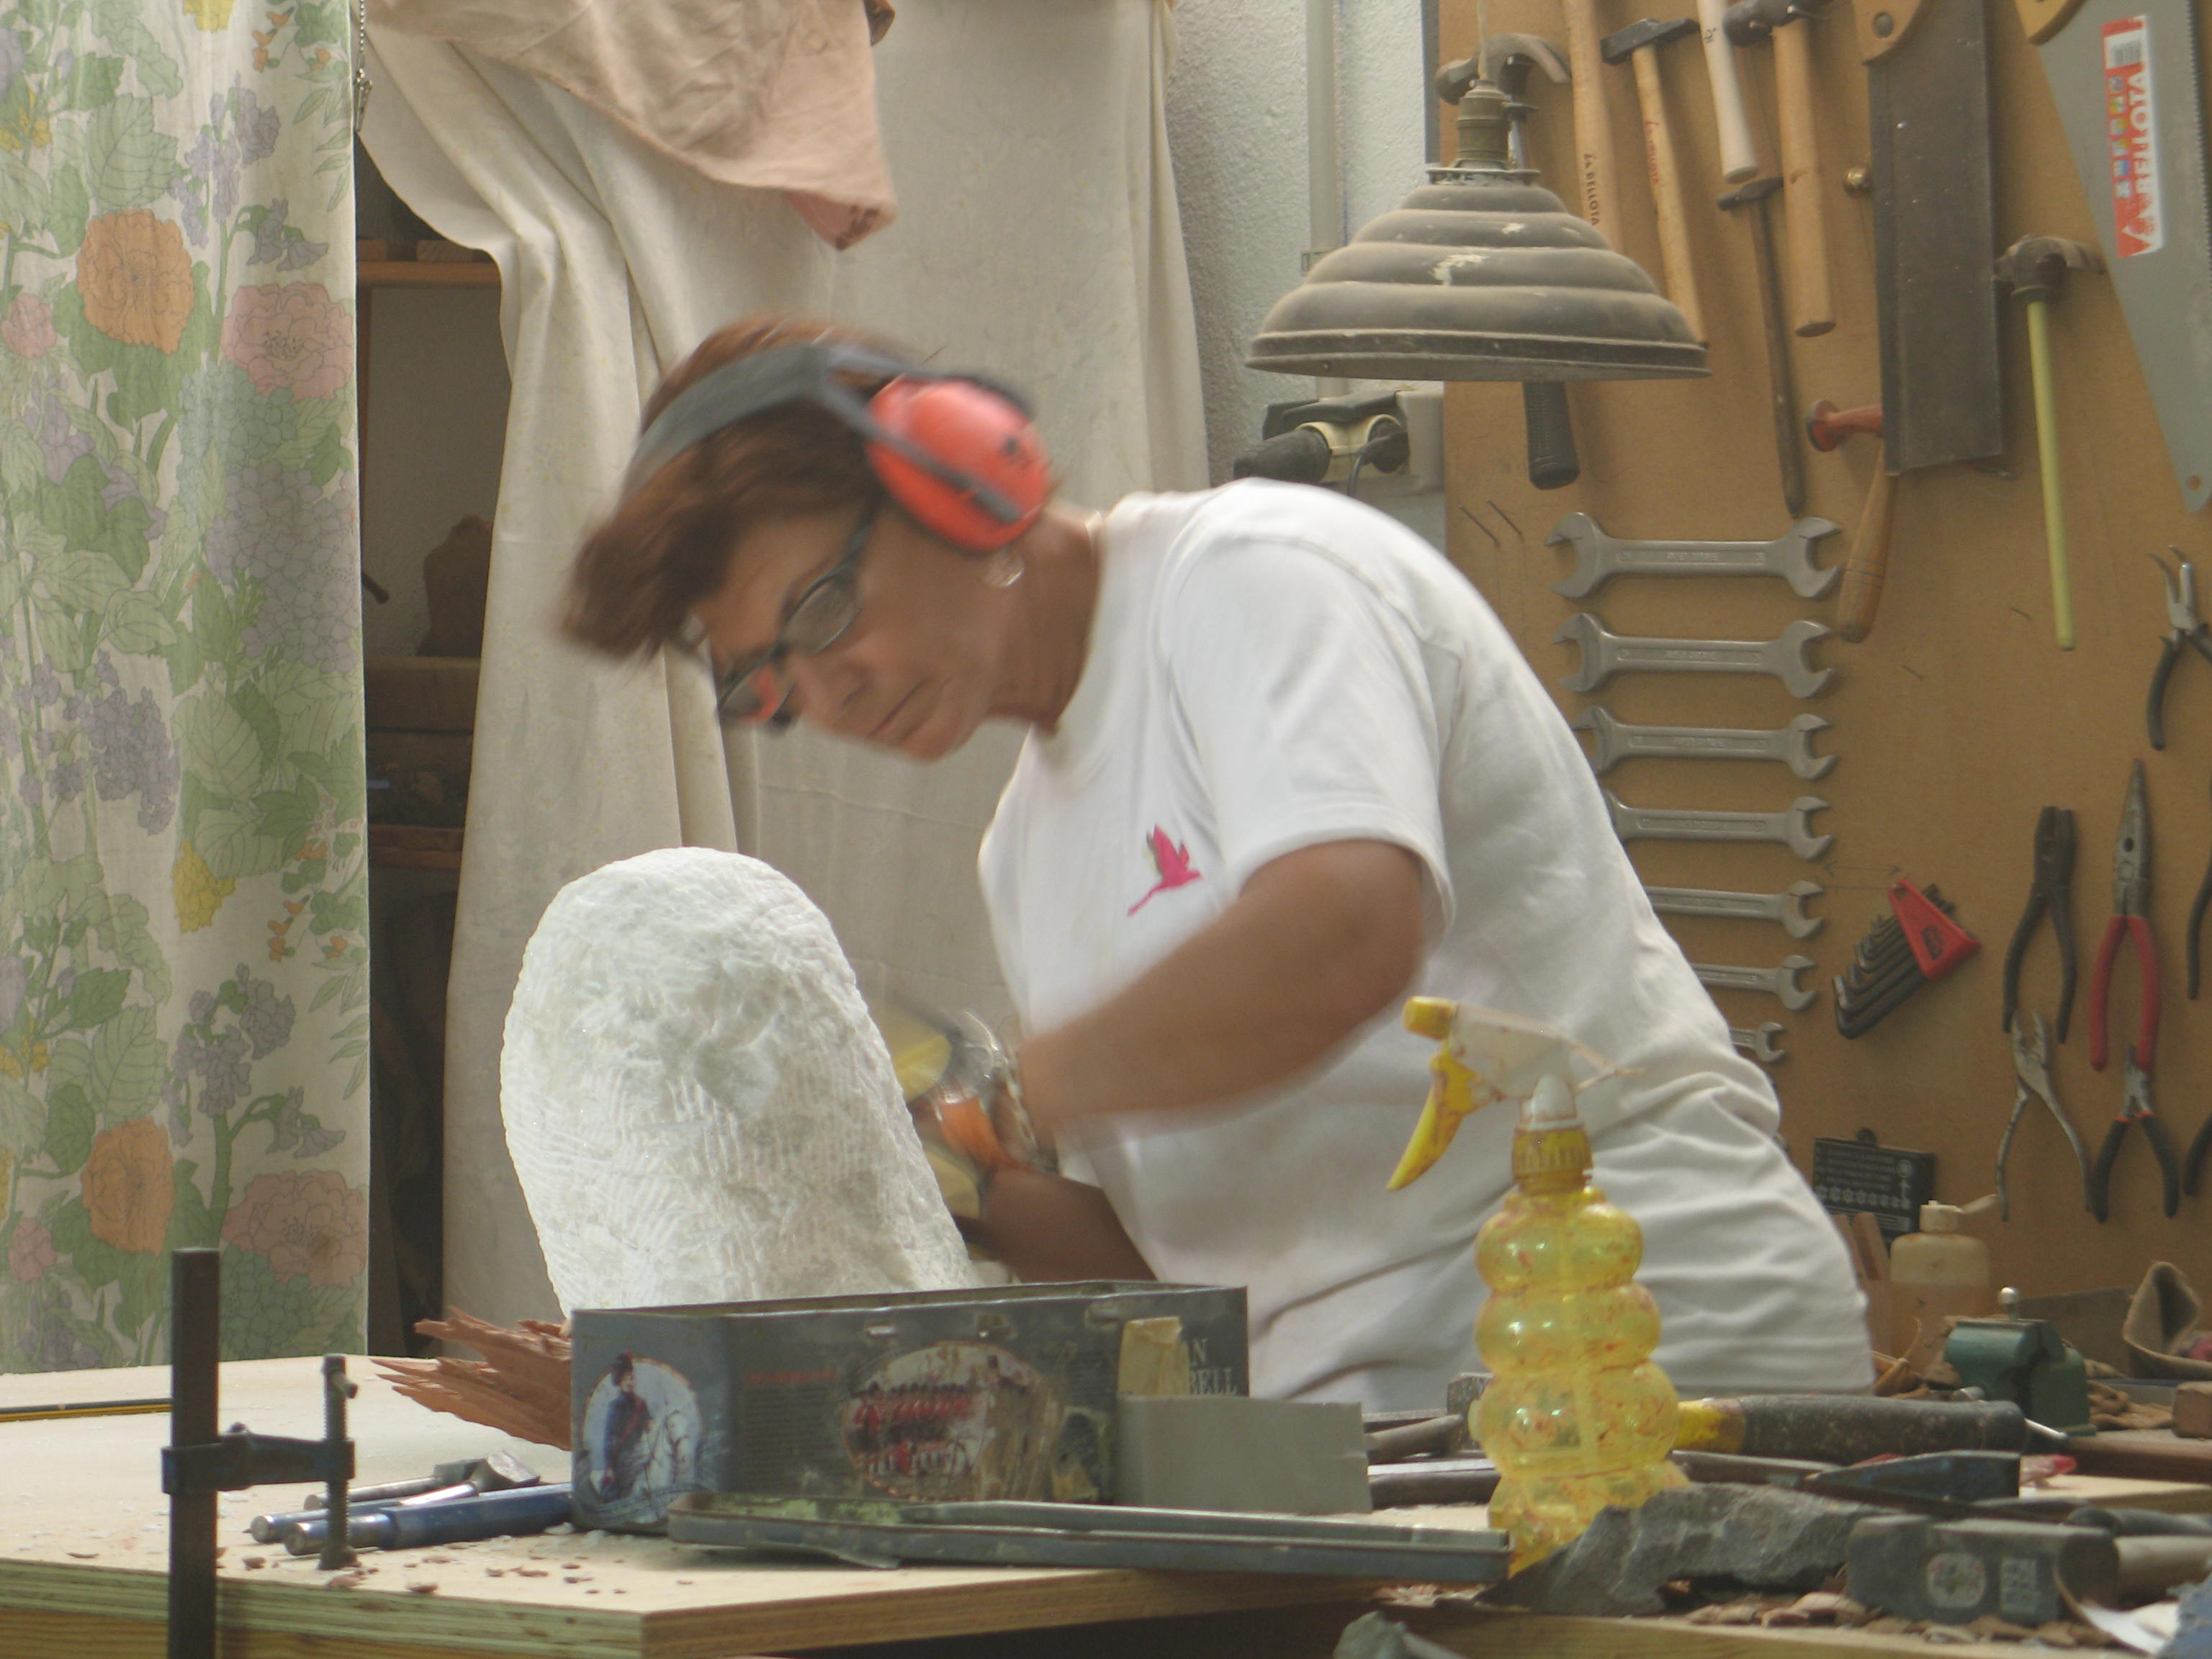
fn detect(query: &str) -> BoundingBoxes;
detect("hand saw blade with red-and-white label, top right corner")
[2015,0,2212,513]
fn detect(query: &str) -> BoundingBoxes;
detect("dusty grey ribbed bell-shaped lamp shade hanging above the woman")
[1246,80,1706,380]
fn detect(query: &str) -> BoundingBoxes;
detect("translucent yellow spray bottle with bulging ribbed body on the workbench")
[1391,997,1683,1570]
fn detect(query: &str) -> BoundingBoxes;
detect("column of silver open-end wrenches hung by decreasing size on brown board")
[1546,513,1845,1066]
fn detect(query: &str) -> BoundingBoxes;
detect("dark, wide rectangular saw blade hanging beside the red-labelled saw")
[1867,0,2004,473]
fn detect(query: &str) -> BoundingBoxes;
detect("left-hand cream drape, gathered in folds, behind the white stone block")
[363,31,834,1321]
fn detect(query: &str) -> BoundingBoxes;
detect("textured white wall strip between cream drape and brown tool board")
[1168,0,1429,480]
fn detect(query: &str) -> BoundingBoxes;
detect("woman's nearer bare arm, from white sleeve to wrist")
[1022,840,1426,1141]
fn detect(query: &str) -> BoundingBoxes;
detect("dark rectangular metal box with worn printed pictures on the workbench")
[571,1281,1248,1531]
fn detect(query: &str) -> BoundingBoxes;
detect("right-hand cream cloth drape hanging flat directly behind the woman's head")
[757,0,1205,1035]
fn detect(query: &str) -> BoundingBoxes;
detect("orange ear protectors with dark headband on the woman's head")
[621,345,1053,553]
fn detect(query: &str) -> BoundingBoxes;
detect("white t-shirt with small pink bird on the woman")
[982,480,1869,1409]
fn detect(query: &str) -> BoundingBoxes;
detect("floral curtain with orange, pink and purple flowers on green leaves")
[0,0,367,1372]
